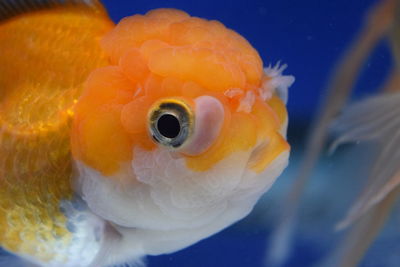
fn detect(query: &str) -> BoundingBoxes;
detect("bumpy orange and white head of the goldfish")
[72,9,293,254]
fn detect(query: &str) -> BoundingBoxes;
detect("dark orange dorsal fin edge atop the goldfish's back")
[0,0,105,21]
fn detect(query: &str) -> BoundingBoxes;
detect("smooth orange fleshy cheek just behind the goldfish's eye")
[71,67,135,175]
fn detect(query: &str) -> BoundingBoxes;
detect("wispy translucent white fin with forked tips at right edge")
[333,93,400,228]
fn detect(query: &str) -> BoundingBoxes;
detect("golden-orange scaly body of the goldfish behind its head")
[0,1,113,266]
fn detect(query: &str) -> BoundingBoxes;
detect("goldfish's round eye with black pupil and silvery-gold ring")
[149,99,194,148]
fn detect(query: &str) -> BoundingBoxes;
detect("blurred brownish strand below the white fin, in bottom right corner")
[320,187,400,267]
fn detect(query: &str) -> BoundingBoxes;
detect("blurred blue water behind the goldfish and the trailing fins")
[99,0,394,267]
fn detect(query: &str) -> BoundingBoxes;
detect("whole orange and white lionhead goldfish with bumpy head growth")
[0,0,294,267]
